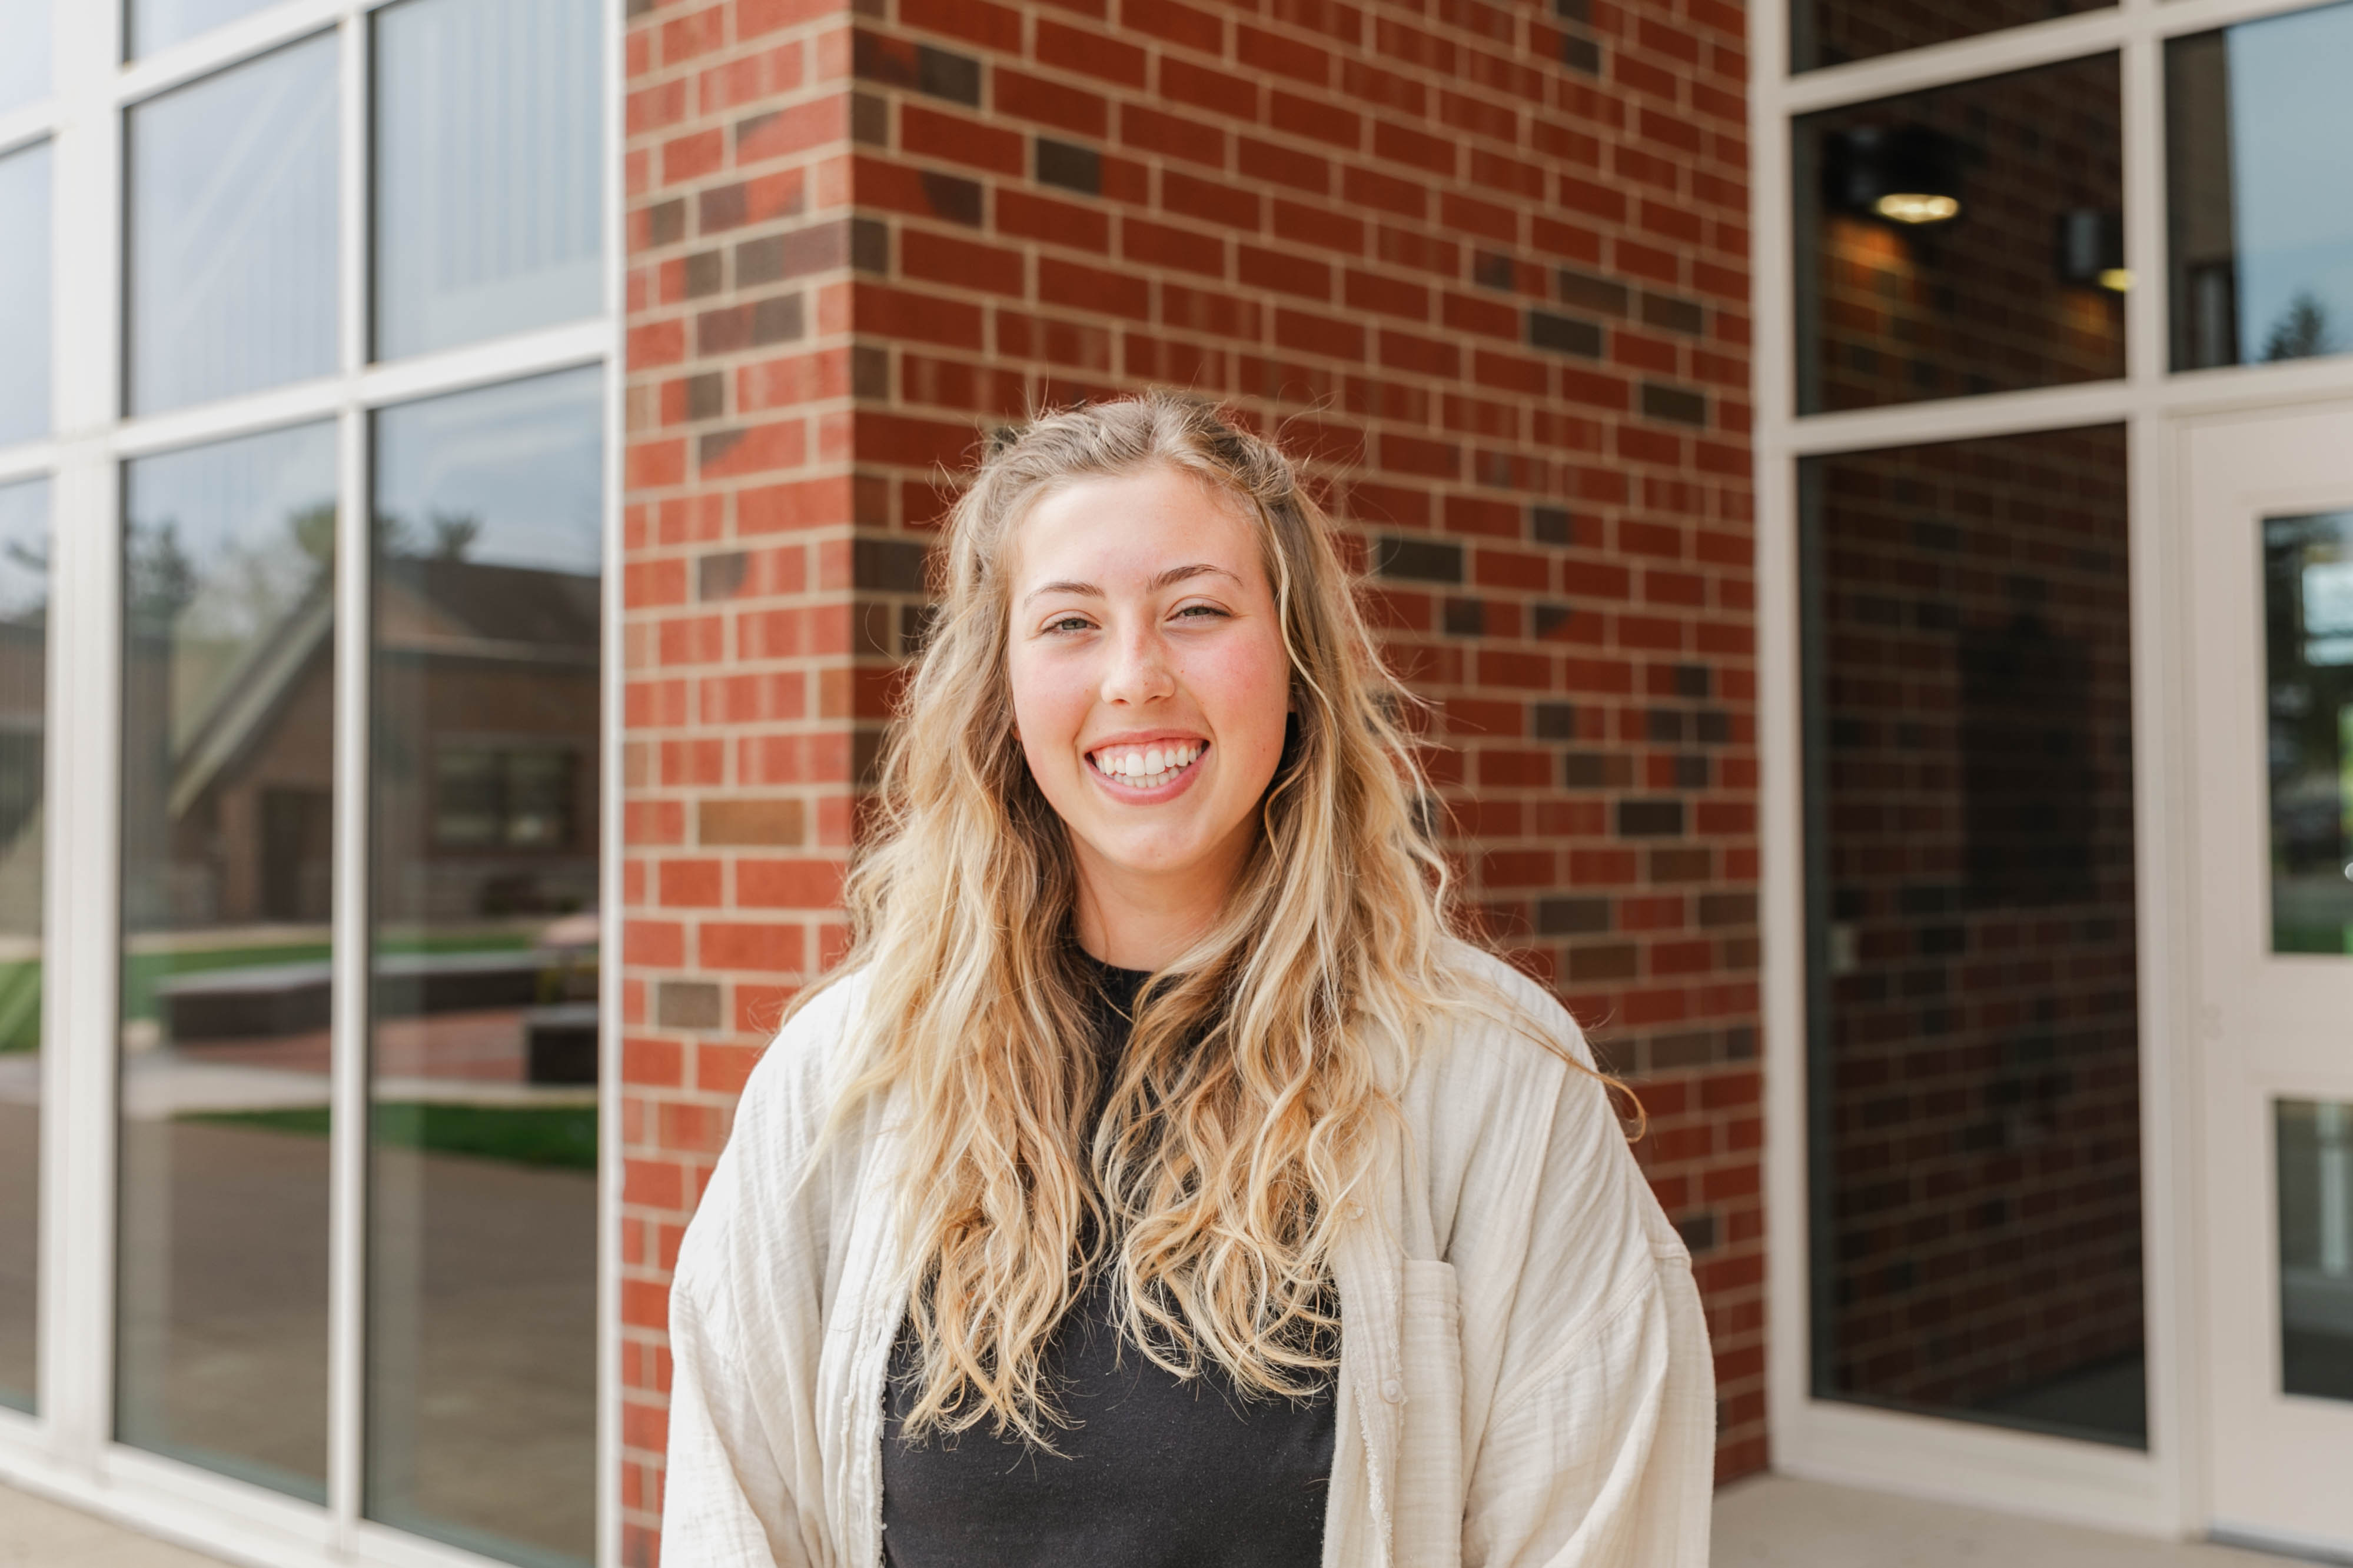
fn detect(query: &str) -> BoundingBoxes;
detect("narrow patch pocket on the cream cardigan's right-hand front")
[1381,1258,1464,1568]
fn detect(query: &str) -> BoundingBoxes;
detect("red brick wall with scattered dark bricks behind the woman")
[621,0,1765,1561]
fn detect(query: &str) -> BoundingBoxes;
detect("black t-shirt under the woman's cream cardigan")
[882,961,1334,1568]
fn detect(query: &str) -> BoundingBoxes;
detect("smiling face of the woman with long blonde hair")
[1007,465,1290,919]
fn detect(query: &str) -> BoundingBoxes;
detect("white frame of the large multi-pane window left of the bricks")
[0,0,626,1568]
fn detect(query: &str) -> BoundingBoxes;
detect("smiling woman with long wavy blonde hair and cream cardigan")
[663,392,1713,1568]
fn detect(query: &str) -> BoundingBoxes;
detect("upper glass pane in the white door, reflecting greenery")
[2264,512,2353,954]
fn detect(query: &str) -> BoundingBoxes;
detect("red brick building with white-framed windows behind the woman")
[0,0,2353,1568]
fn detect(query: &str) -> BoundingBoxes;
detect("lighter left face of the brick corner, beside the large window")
[614,0,861,1563]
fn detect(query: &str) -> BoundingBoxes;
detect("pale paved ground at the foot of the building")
[0,1476,2325,1568]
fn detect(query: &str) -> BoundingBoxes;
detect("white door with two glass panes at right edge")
[2183,407,2353,1556]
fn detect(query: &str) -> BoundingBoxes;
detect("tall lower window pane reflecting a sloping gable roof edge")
[115,423,337,1500]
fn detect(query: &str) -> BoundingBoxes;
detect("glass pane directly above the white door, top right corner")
[2165,5,2353,369]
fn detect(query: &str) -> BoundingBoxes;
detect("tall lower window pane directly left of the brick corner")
[367,369,602,1563]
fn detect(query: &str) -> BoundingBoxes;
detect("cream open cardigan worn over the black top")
[661,957,1716,1568]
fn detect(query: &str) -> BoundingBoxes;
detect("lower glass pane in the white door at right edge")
[2273,1100,2353,1399]
